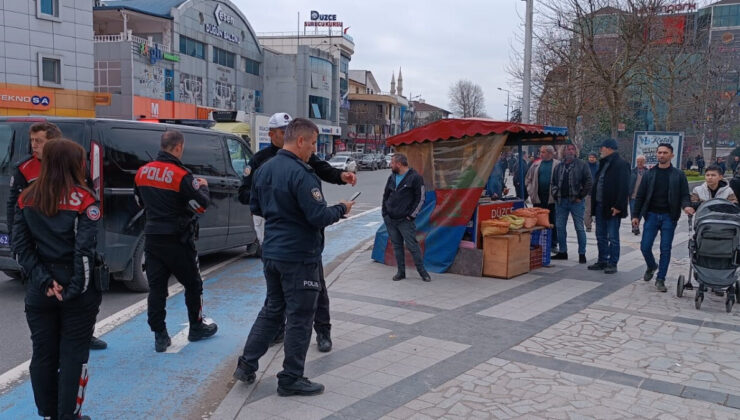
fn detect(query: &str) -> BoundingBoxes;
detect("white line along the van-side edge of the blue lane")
[0,251,243,393]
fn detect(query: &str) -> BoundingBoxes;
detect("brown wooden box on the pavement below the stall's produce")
[483,232,531,279]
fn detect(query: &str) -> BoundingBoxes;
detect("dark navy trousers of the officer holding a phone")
[239,258,322,385]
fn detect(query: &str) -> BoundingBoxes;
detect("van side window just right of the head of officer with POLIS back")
[182,132,228,177]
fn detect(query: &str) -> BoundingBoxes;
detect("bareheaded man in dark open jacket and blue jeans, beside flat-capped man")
[551,144,592,264]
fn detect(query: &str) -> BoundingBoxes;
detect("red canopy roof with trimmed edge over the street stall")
[386,118,568,146]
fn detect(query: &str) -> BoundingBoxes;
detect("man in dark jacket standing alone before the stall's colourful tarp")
[382,153,432,281]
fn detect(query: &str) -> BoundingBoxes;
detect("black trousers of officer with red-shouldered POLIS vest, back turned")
[144,235,203,332]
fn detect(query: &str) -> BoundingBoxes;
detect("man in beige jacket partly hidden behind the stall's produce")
[524,146,560,253]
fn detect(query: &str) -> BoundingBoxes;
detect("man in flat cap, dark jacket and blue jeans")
[588,139,630,274]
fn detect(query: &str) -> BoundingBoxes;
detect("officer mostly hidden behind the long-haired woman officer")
[5,121,108,350]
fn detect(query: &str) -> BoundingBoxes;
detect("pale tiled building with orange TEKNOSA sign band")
[0,0,99,117]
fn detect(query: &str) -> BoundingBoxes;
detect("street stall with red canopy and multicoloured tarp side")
[372,118,567,273]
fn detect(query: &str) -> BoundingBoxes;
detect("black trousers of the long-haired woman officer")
[25,285,102,420]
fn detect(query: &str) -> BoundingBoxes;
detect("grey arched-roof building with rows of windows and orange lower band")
[94,0,264,119]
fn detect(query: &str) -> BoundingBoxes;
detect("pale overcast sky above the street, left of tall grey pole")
[232,0,525,120]
